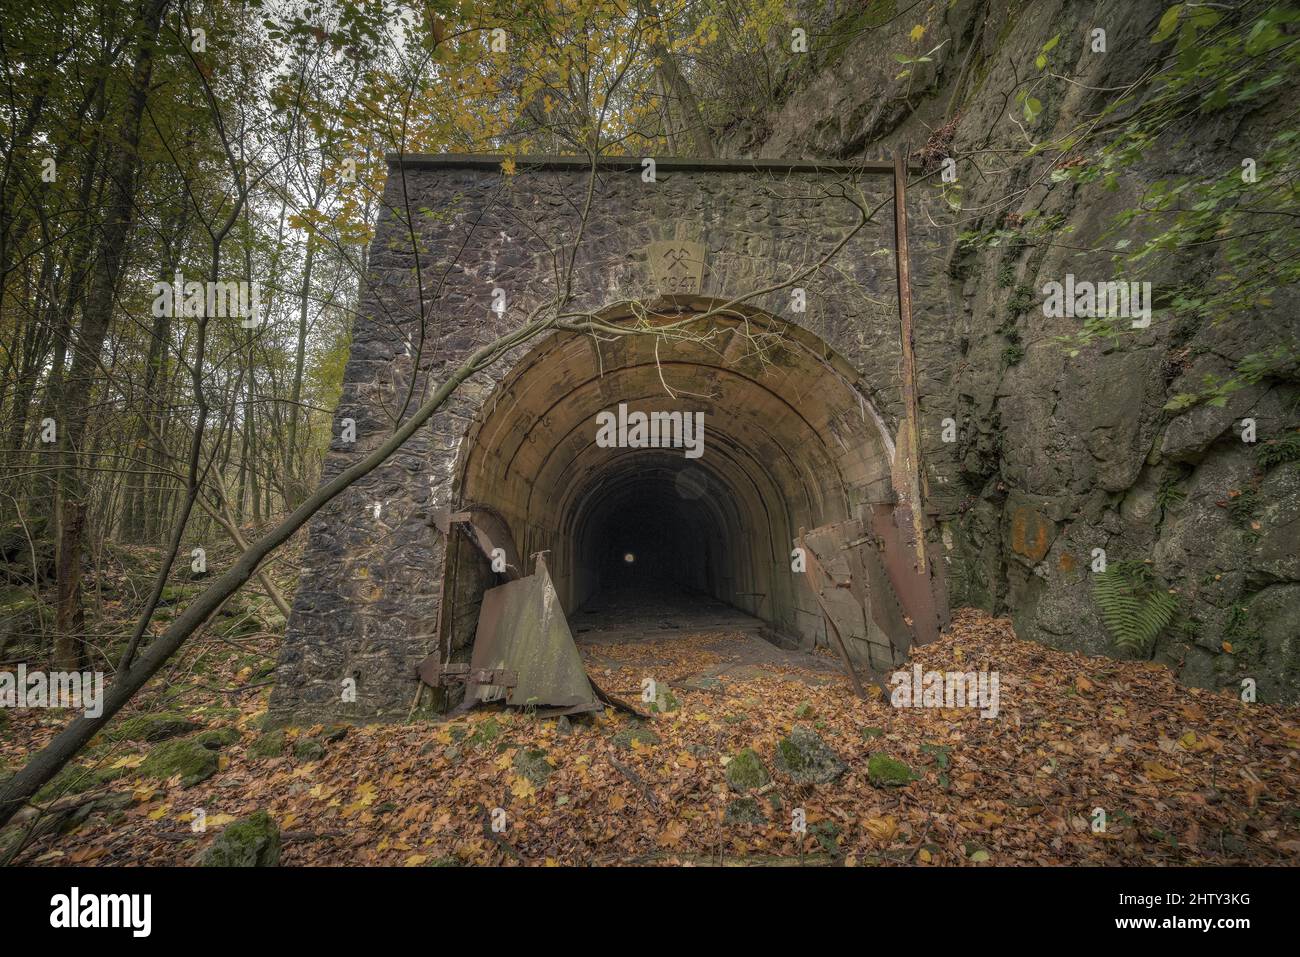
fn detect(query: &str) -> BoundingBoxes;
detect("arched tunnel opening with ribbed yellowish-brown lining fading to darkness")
[445,303,915,667]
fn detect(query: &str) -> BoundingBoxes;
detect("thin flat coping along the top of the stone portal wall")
[385,153,920,177]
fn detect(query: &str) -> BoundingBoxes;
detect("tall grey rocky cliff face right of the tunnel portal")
[729,0,1300,702]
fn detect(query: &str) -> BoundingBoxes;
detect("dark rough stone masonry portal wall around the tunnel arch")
[272,161,949,719]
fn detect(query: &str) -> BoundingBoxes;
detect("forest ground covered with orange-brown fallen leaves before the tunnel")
[0,611,1300,866]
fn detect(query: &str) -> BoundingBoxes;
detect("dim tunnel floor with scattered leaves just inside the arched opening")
[569,585,841,694]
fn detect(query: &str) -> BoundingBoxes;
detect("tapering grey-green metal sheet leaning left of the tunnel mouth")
[465,557,602,714]
